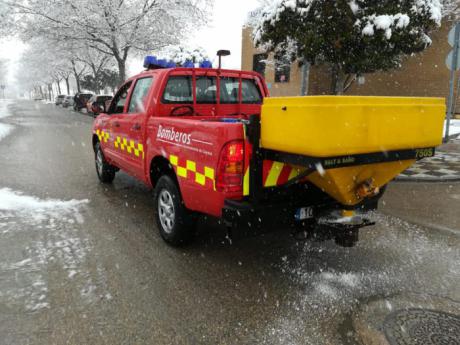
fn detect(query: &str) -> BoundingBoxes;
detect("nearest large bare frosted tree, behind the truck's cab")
[3,0,211,82]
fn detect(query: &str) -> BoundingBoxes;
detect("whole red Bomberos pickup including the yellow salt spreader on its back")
[92,52,445,246]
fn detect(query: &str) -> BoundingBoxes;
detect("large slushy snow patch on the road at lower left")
[0,188,100,311]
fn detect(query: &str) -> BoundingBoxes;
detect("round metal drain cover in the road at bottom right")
[383,308,460,345]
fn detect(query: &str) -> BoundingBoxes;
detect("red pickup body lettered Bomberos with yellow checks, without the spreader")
[93,62,274,245]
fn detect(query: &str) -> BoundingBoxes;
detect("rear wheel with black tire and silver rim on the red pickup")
[154,175,195,247]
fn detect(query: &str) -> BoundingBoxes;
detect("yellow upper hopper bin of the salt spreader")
[261,96,445,157]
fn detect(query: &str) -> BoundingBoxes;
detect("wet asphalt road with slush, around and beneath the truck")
[0,101,460,345]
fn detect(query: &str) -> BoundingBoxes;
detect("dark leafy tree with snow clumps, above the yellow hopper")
[251,0,451,93]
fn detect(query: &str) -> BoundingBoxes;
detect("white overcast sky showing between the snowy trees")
[0,0,258,84]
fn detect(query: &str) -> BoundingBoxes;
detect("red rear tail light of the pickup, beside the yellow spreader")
[216,141,244,192]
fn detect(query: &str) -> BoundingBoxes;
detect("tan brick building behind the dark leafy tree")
[241,21,460,102]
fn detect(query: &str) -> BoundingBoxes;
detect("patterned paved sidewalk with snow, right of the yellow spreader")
[396,138,460,182]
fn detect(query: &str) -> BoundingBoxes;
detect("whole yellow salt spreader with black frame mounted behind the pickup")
[234,96,445,246]
